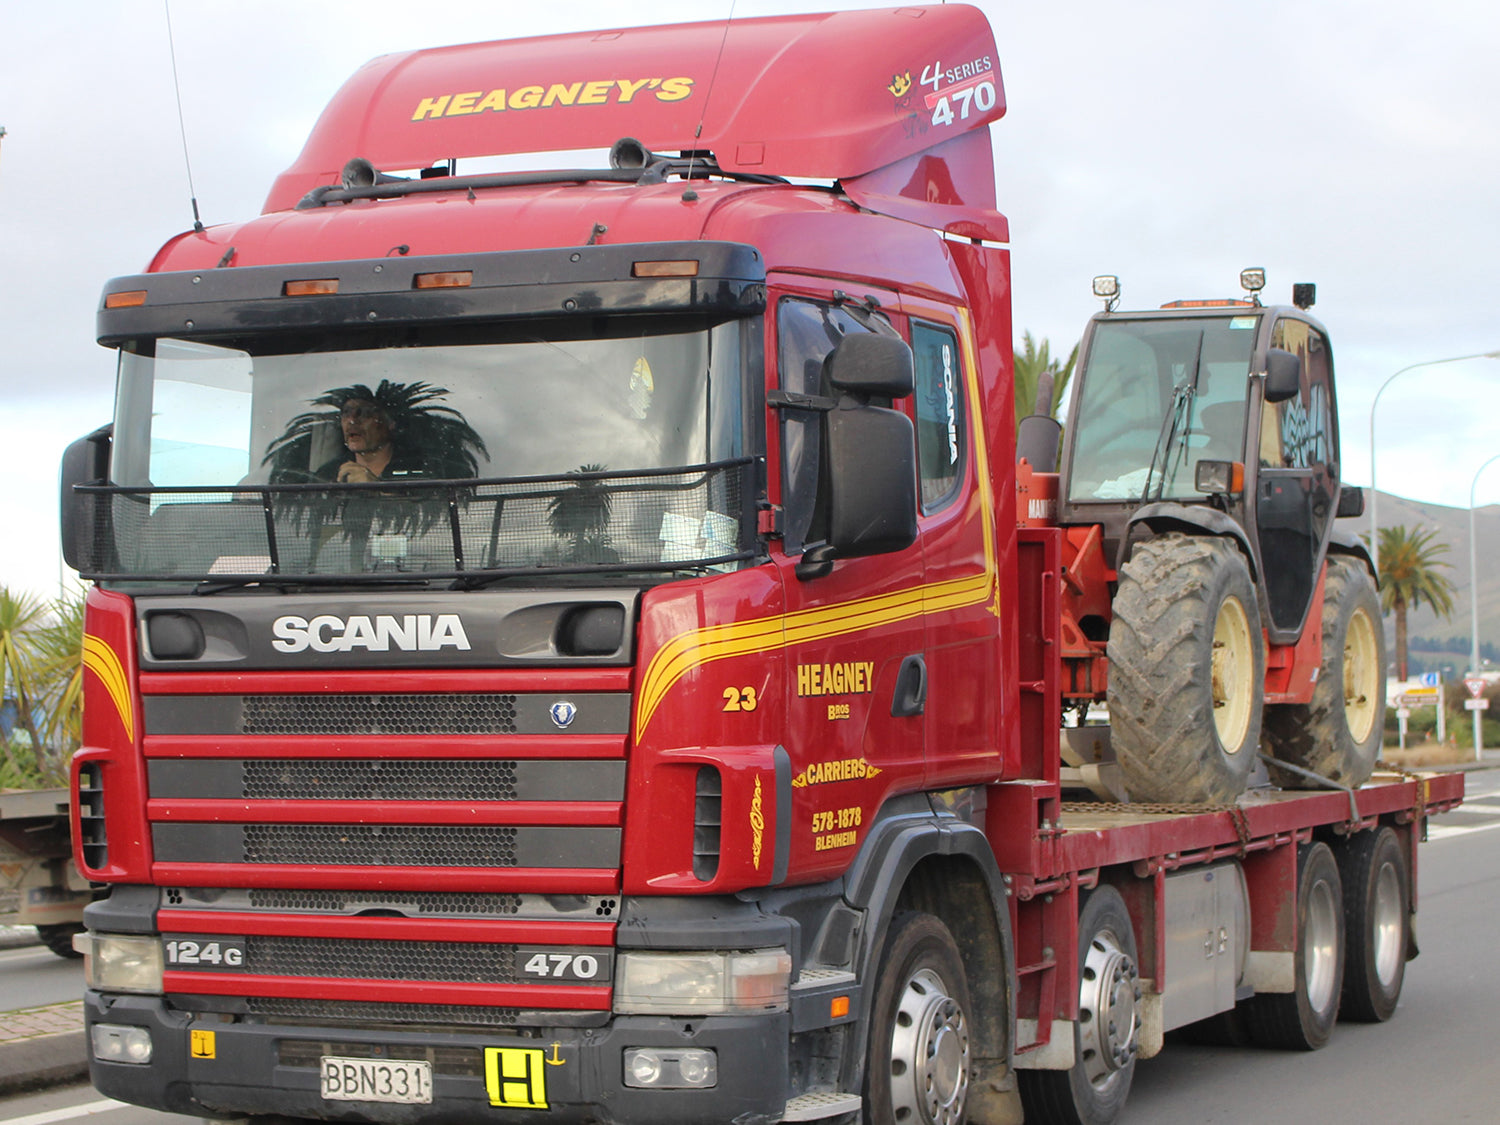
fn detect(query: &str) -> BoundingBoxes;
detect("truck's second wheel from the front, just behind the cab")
[1017,887,1140,1125]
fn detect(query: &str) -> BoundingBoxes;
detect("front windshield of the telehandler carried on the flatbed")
[1068,315,1260,503]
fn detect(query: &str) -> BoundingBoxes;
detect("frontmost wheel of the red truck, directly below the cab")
[864,914,974,1125]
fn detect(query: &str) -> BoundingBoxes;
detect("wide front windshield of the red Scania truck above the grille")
[98,321,755,578]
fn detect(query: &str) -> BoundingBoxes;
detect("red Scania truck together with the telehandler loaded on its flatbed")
[63,5,1463,1125]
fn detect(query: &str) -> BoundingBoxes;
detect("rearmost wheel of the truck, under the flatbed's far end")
[1338,827,1412,1023]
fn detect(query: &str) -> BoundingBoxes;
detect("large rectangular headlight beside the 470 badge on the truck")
[615,950,792,1016]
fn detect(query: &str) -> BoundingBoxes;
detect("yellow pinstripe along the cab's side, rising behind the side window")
[636,309,1001,732]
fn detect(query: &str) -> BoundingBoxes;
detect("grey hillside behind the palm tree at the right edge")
[1338,491,1500,672]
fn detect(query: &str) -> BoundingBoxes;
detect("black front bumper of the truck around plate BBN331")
[84,992,791,1125]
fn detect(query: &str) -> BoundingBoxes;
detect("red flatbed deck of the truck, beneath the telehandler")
[989,773,1464,1067]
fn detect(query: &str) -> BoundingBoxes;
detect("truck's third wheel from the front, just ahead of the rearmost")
[1245,843,1344,1050]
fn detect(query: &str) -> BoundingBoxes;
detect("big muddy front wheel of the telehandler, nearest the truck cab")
[1109,533,1266,803]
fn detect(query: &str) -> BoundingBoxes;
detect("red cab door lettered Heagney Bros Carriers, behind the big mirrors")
[768,278,927,873]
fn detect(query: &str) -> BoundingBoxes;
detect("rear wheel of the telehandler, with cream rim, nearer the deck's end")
[1266,558,1386,789]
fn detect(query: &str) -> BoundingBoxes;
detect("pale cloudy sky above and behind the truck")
[0,0,1500,596]
